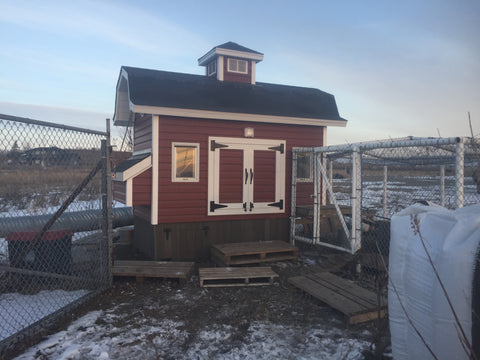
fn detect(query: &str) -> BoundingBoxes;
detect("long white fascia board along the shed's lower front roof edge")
[133,105,347,127]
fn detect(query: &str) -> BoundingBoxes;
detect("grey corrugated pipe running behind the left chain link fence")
[0,207,133,237]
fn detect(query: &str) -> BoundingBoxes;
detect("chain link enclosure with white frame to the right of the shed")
[291,137,480,277]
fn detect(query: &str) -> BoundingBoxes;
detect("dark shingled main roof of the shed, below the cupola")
[123,67,345,121]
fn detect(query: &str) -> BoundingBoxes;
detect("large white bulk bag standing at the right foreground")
[388,204,480,359]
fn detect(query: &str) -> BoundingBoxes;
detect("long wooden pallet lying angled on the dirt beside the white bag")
[288,272,387,324]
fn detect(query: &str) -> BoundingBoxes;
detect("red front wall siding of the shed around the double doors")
[153,117,323,223]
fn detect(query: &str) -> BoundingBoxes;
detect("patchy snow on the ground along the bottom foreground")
[16,311,369,360]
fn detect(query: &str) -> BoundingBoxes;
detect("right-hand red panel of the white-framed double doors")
[253,150,276,202]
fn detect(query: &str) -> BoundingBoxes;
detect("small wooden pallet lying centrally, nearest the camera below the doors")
[198,267,278,287]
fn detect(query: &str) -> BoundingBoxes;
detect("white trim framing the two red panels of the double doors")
[207,137,286,216]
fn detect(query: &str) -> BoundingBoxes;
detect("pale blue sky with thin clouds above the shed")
[0,0,480,145]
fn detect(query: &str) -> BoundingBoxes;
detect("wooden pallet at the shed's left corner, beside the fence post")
[112,260,195,283]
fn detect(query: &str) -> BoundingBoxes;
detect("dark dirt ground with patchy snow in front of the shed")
[9,244,390,359]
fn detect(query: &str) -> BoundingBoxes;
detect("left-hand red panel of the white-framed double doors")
[219,149,244,203]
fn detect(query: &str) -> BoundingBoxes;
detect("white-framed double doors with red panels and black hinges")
[208,137,286,215]
